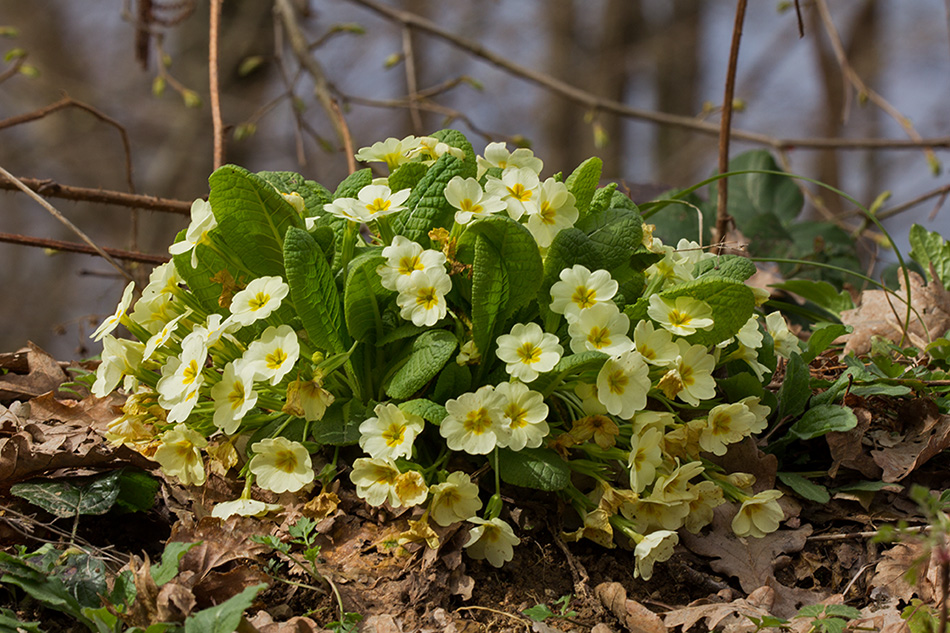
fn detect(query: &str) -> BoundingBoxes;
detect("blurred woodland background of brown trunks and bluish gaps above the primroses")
[0,0,950,359]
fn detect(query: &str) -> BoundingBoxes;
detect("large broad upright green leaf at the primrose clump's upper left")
[208,165,303,277]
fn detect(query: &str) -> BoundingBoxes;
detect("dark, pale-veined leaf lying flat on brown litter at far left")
[10,470,122,518]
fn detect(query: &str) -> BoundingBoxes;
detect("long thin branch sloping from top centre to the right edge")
[346,0,950,150]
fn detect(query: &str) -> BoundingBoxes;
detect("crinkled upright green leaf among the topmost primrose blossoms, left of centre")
[390,154,475,243]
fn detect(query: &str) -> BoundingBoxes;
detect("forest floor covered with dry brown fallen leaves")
[0,348,950,633]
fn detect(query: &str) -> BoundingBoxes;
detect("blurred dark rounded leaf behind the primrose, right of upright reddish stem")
[727,150,805,228]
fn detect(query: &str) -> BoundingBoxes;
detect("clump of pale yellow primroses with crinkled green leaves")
[94,130,797,578]
